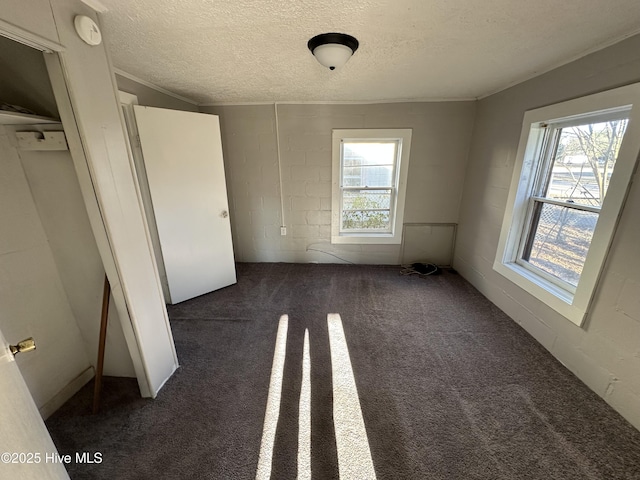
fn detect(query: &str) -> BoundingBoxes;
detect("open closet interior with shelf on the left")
[0,32,136,419]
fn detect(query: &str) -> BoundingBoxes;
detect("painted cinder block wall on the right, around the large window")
[454,36,640,428]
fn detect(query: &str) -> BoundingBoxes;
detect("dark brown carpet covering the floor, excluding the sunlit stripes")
[47,264,640,480]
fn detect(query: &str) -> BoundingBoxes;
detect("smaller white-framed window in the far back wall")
[331,129,411,244]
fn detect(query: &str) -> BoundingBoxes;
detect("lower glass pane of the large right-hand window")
[522,202,598,286]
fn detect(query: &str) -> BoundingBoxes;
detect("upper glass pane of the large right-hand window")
[542,119,628,207]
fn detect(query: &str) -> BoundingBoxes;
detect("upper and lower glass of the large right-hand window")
[521,118,628,289]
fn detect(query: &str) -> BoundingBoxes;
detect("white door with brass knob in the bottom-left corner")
[0,331,69,480]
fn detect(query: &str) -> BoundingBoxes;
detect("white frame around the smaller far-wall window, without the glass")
[331,128,412,244]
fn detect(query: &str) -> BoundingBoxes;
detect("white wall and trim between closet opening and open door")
[0,0,178,396]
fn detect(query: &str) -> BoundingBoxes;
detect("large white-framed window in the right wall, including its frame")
[494,84,640,325]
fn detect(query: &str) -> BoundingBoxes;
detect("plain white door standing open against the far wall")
[134,105,236,303]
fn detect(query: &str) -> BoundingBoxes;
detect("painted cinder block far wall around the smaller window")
[200,102,476,264]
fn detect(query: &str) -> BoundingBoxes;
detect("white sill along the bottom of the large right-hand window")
[493,262,586,326]
